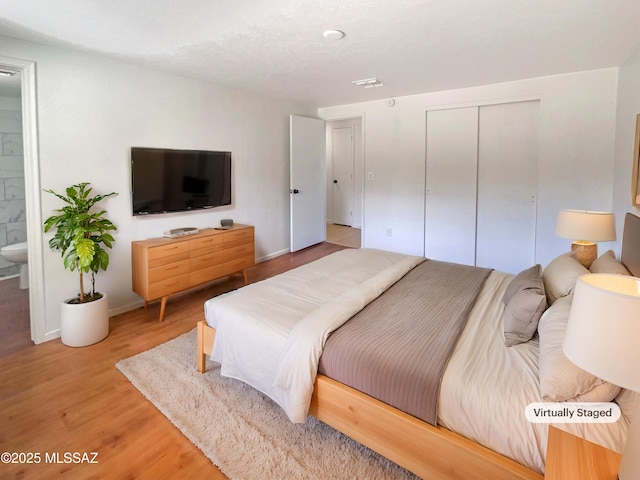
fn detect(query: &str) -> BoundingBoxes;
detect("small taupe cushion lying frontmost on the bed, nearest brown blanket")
[502,265,547,347]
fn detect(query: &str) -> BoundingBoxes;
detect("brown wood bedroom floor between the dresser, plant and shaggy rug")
[0,243,344,480]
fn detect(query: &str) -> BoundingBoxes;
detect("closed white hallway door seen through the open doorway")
[331,127,354,226]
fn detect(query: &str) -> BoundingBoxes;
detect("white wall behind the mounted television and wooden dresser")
[0,37,315,341]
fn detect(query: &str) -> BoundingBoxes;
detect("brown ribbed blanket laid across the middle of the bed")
[318,260,491,425]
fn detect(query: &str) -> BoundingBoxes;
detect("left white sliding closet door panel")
[425,107,478,265]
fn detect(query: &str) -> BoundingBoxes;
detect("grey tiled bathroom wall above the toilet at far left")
[0,110,27,276]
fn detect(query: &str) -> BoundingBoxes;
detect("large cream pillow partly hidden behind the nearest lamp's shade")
[538,295,620,402]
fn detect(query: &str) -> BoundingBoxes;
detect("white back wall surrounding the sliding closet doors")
[318,68,618,265]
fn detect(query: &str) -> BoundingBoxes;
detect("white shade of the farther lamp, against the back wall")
[556,210,616,242]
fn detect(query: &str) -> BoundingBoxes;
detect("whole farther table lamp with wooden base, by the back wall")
[556,209,616,268]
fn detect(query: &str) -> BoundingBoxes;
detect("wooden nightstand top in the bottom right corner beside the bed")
[544,426,621,480]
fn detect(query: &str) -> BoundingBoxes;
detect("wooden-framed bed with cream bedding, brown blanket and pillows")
[198,214,640,479]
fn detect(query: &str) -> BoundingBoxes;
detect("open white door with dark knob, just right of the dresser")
[289,115,327,252]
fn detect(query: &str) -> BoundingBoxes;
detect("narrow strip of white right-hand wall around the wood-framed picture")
[613,41,640,248]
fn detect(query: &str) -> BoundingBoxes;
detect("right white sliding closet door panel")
[476,101,539,273]
